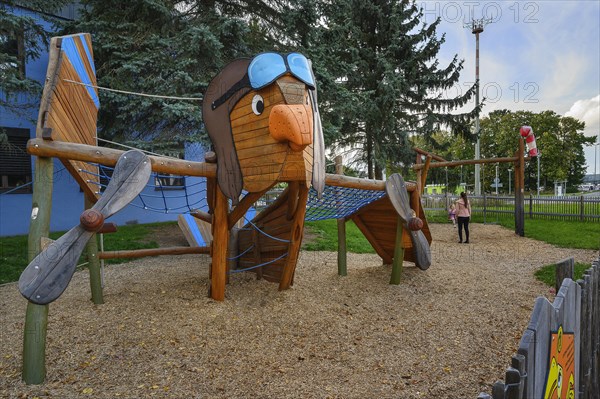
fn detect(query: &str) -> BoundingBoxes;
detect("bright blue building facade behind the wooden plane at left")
[0,4,206,236]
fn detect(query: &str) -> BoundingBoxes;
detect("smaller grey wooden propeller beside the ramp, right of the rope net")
[385,173,431,270]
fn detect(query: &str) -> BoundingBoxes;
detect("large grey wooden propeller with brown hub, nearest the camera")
[19,150,152,305]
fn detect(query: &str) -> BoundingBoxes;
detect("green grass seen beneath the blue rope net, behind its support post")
[303,219,375,254]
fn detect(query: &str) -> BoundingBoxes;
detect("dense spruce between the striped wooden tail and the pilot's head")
[69,0,302,148]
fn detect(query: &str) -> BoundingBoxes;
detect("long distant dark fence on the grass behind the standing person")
[422,194,600,222]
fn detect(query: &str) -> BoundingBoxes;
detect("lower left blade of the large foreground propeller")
[19,225,94,305]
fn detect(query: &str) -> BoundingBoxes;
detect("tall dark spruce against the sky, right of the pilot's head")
[318,0,476,178]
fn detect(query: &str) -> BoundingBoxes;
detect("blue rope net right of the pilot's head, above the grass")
[305,186,386,221]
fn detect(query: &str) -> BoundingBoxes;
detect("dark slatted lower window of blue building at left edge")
[0,127,32,194]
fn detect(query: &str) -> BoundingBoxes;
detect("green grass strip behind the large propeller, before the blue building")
[0,222,165,284]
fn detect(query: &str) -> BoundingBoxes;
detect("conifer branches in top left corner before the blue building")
[0,0,69,118]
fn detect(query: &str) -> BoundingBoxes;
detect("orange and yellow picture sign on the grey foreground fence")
[544,326,575,399]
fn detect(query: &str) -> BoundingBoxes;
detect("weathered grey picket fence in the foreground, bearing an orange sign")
[478,258,600,399]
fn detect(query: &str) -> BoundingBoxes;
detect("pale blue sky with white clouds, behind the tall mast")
[417,0,600,174]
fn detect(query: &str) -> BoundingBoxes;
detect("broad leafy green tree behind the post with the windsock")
[481,110,594,190]
